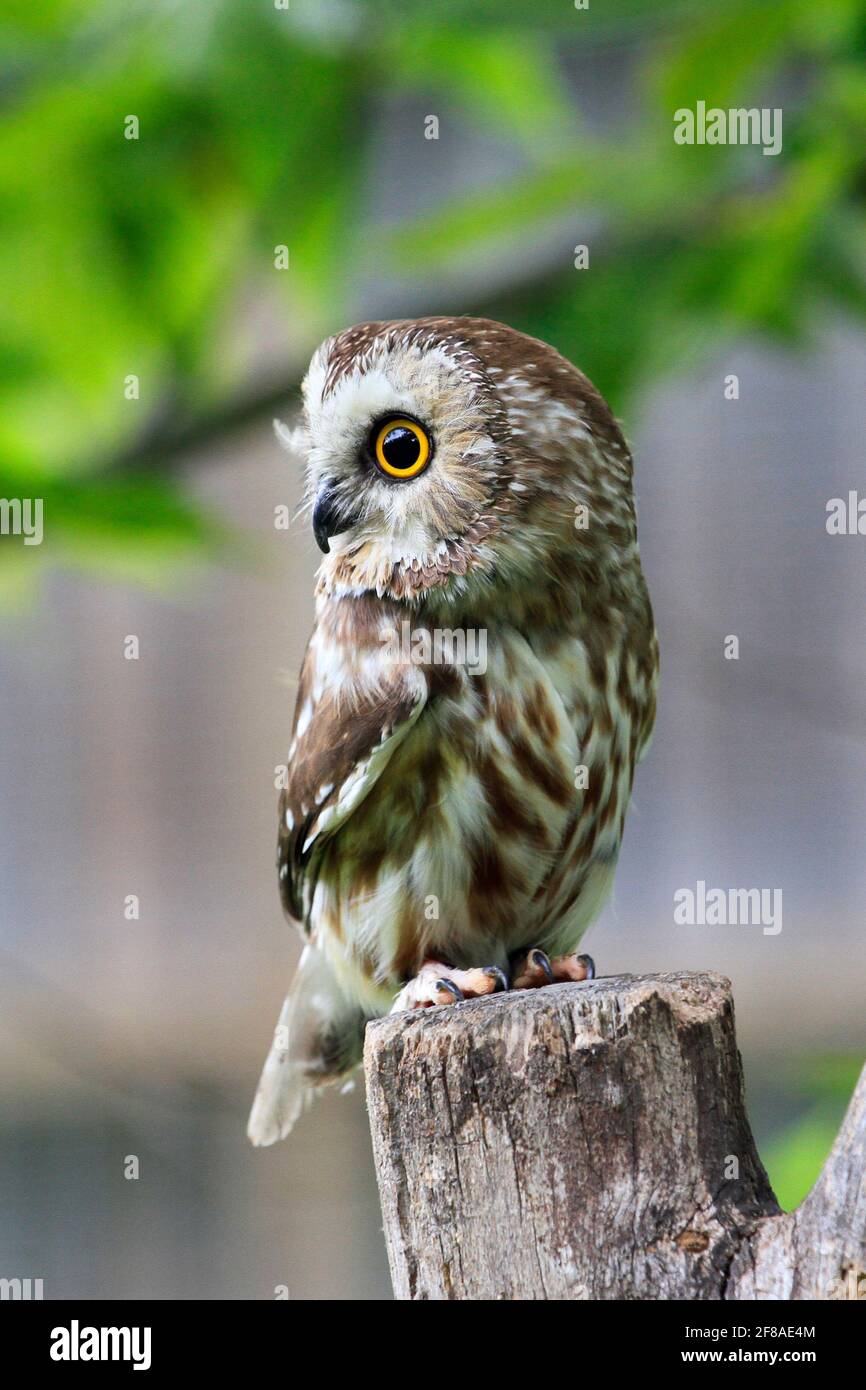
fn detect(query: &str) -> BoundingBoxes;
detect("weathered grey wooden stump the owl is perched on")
[366,973,866,1300]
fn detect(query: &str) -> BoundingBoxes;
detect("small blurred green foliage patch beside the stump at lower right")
[762,1056,862,1211]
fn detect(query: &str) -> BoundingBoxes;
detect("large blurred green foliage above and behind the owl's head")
[0,0,866,598]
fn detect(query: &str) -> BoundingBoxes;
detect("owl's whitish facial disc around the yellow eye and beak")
[303,332,503,594]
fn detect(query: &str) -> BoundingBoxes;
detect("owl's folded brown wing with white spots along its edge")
[277,651,428,929]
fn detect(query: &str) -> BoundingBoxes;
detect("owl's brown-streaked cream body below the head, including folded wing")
[278,595,656,1011]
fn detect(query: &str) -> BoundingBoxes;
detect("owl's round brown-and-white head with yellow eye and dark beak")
[283,318,637,605]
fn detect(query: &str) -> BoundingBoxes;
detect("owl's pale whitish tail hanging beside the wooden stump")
[246,945,366,1147]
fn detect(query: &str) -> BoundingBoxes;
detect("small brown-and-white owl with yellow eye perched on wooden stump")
[249,317,657,1144]
